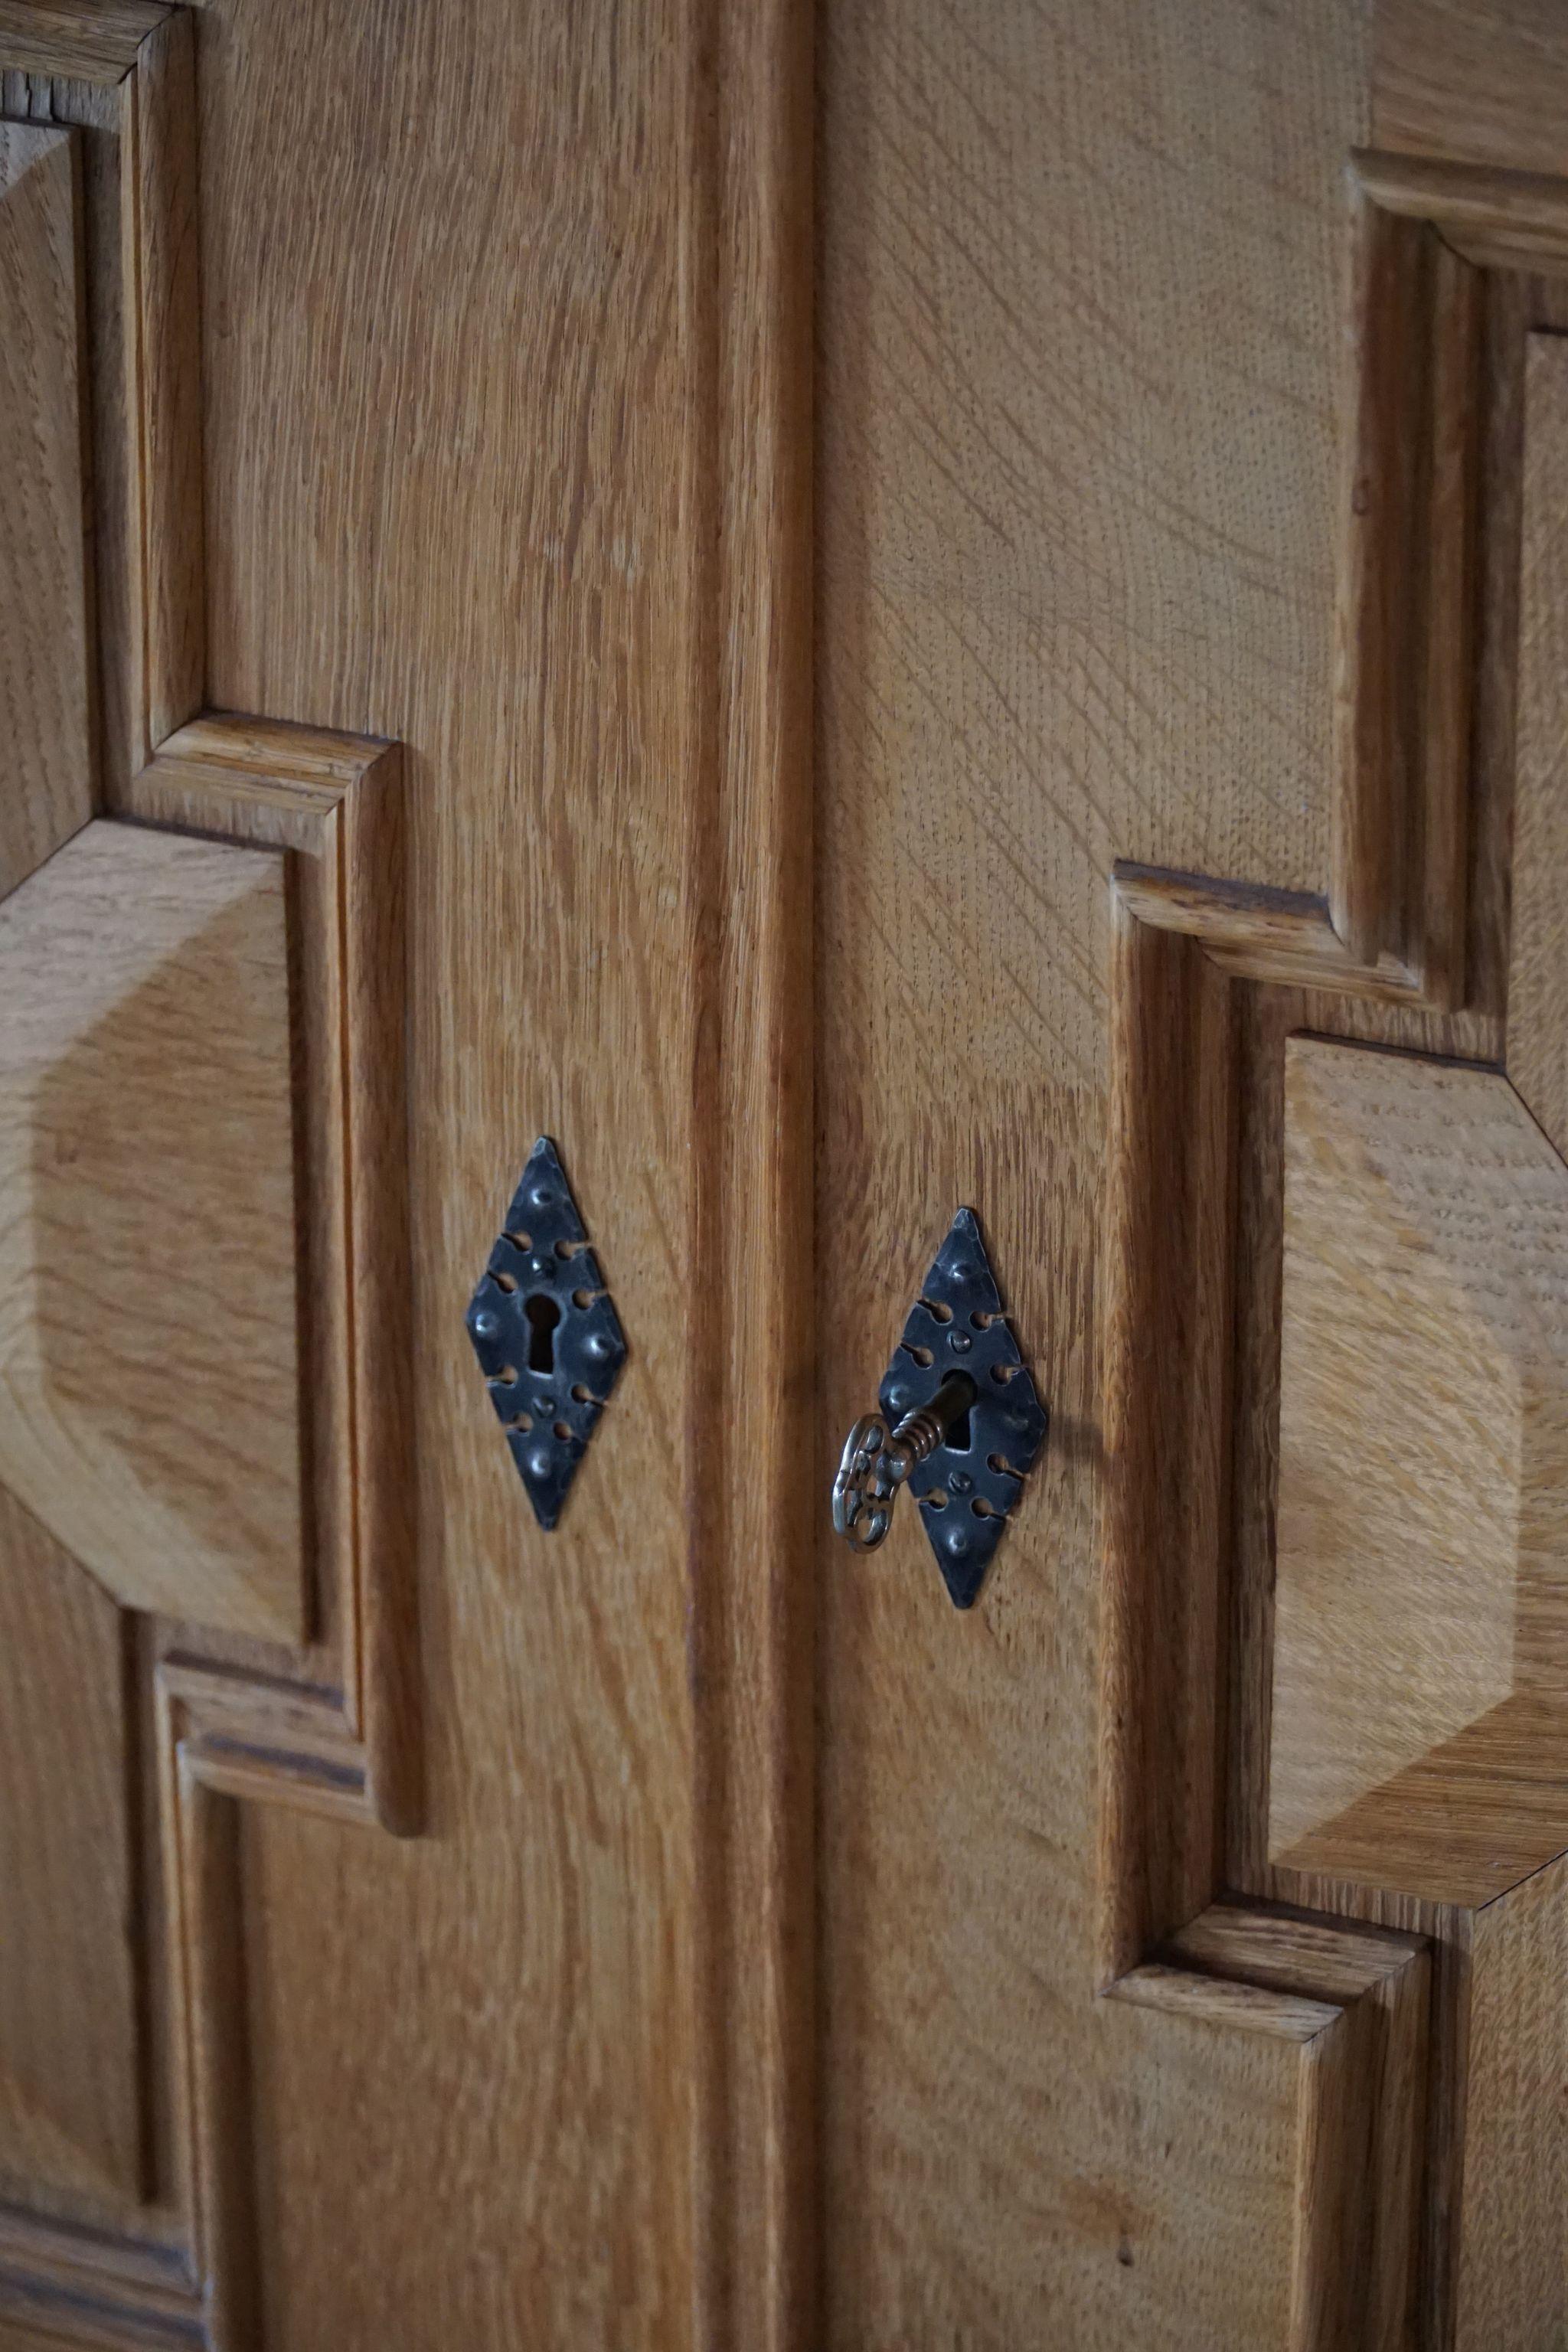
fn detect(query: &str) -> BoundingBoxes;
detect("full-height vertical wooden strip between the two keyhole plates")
[679,0,818,2352]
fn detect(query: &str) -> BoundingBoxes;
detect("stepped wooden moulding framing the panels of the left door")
[0,0,421,2352]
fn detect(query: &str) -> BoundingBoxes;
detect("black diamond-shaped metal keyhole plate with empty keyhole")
[468,1136,626,1529]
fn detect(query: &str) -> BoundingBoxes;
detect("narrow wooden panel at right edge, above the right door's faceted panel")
[1507,334,1568,1152]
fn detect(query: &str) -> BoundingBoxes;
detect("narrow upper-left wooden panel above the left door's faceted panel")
[0,122,94,893]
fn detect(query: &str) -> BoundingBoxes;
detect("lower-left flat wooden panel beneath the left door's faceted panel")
[0,1491,143,2211]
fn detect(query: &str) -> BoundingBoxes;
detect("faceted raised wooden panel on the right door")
[1269,1040,1568,1903]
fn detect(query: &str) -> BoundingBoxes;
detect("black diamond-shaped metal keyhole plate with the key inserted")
[877,1209,1050,1609]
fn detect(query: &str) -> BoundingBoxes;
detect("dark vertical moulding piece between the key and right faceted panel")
[1100,908,1234,1981]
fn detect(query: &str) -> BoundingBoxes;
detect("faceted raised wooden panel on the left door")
[0,823,303,1639]
